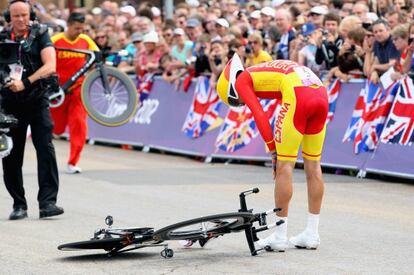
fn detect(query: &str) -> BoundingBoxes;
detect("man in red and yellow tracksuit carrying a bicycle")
[51,12,99,174]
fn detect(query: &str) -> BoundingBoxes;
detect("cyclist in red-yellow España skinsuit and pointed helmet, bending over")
[217,54,328,251]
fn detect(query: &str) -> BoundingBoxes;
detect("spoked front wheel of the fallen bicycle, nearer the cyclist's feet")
[153,213,254,241]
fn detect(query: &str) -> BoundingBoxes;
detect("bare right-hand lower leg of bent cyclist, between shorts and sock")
[304,159,324,215]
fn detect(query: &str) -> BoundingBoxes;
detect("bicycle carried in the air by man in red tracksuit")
[49,48,138,126]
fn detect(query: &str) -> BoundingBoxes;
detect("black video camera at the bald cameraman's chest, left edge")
[0,41,20,89]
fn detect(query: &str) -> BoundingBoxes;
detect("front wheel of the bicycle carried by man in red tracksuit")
[81,66,138,127]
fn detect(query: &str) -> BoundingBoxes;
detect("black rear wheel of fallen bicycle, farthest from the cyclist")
[58,237,128,251]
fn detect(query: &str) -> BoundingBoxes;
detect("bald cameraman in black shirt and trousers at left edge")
[1,0,63,220]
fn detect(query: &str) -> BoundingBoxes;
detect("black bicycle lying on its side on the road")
[58,188,283,258]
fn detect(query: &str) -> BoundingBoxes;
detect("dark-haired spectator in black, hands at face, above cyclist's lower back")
[315,13,344,70]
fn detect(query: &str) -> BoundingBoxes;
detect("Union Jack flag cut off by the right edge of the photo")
[381,77,414,145]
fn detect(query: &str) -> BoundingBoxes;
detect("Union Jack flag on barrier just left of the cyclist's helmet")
[182,76,221,138]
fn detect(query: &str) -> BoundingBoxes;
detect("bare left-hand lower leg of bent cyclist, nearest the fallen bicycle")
[274,160,295,217]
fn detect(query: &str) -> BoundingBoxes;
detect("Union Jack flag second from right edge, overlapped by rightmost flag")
[343,80,400,154]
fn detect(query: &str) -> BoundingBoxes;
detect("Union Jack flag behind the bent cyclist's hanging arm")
[216,99,278,152]
